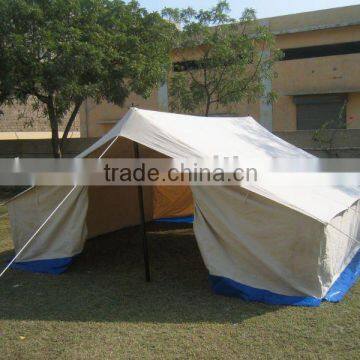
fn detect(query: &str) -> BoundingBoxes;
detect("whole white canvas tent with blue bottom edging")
[3,108,360,306]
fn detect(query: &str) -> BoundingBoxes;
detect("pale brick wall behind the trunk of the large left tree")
[0,102,80,132]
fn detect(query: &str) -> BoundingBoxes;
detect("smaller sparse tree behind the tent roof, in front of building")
[162,1,281,116]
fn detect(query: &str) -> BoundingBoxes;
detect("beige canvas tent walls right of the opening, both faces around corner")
[193,187,360,306]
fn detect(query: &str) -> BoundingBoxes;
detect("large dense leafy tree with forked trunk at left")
[0,0,174,157]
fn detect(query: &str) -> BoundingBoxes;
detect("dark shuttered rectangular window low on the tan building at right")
[294,94,347,130]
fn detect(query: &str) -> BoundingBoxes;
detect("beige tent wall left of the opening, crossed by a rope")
[8,186,88,273]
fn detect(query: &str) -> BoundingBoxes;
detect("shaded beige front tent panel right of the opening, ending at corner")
[193,187,325,305]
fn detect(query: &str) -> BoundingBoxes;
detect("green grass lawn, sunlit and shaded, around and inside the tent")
[0,204,360,359]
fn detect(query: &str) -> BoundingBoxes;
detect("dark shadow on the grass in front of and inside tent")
[0,228,279,323]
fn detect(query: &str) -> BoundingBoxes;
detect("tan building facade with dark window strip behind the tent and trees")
[80,5,360,137]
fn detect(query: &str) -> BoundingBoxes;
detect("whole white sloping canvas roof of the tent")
[79,108,360,223]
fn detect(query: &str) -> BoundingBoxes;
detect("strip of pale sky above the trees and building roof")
[138,0,360,18]
